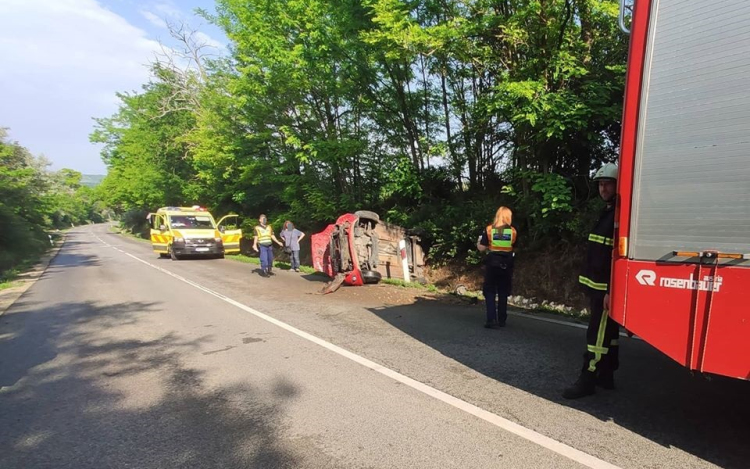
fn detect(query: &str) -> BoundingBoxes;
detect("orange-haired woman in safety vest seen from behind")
[477,207,517,329]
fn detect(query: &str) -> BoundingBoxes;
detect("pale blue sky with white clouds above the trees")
[0,0,227,174]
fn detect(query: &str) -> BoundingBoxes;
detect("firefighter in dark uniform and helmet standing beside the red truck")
[563,163,620,399]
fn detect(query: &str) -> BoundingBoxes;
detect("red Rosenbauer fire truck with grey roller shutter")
[611,0,750,379]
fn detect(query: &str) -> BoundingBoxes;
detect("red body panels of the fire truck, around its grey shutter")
[610,0,750,379]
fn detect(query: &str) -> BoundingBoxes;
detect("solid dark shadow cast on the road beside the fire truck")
[370,298,750,468]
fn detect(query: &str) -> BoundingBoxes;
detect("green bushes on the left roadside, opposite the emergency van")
[0,128,105,279]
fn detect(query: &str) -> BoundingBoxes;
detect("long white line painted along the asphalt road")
[92,233,620,469]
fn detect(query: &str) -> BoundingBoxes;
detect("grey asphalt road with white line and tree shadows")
[0,226,750,468]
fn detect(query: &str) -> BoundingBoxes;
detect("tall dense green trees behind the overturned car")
[92,0,627,262]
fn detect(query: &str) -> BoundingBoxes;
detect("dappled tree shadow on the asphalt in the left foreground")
[0,298,308,468]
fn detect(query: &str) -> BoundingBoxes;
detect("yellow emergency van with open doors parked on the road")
[148,206,242,260]
